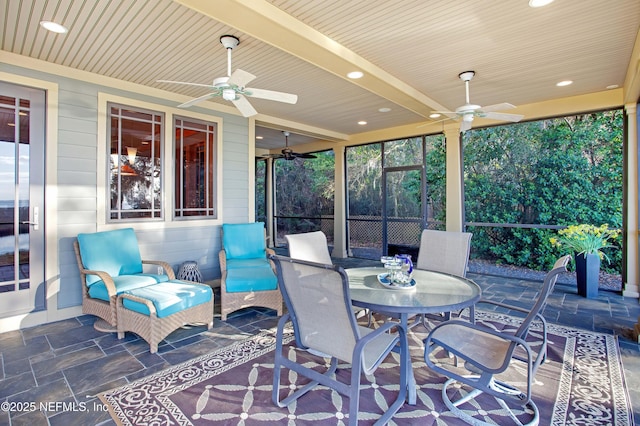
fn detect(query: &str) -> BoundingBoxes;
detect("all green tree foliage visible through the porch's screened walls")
[256,110,623,272]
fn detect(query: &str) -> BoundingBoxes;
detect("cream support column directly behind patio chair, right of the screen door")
[444,125,464,231]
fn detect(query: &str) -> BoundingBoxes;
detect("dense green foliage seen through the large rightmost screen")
[463,110,623,271]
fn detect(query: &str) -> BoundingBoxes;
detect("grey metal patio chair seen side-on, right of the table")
[424,256,570,425]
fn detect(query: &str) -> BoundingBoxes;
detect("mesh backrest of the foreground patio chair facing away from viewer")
[269,256,360,362]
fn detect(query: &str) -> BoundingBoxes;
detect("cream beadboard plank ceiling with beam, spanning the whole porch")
[0,0,640,148]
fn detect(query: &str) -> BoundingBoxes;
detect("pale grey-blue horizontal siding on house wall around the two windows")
[0,64,253,309]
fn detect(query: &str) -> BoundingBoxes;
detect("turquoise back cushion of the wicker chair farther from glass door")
[222,222,267,259]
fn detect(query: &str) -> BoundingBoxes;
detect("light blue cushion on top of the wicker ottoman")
[122,280,213,318]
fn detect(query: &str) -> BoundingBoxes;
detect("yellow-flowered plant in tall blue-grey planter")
[549,224,620,298]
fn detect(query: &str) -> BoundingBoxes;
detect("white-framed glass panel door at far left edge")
[0,83,46,317]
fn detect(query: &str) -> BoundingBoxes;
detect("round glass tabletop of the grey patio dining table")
[346,268,482,314]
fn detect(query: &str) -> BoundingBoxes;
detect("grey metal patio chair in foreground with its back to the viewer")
[269,256,411,426]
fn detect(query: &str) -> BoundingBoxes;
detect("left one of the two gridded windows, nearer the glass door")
[108,105,163,221]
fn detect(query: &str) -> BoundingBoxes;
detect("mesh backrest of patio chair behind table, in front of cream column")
[416,229,473,277]
